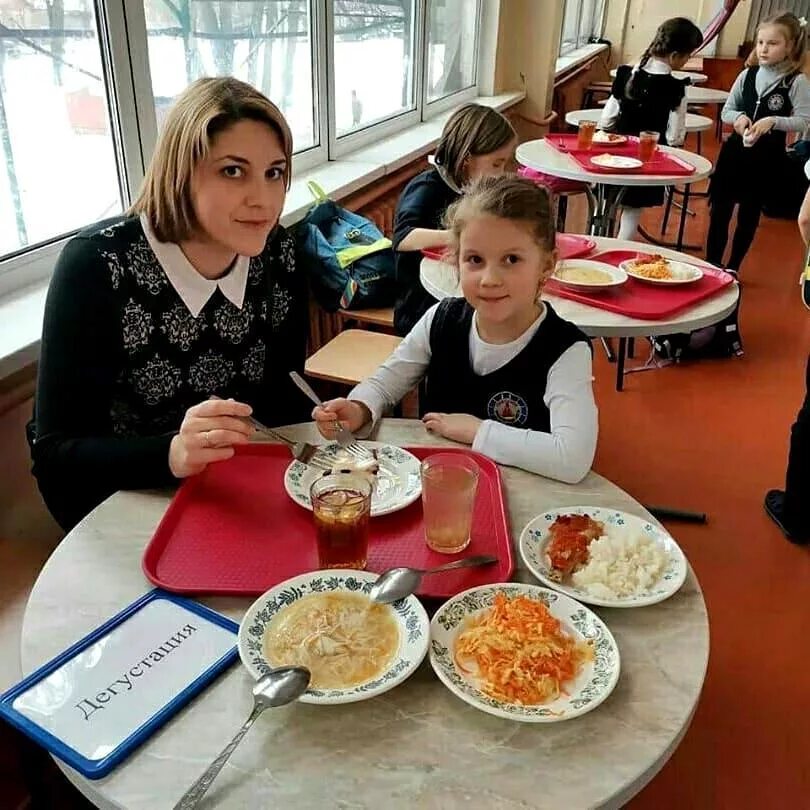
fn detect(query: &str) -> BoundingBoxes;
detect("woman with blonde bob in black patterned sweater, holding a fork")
[29,78,309,530]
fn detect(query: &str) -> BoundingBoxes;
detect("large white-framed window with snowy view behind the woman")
[0,0,480,288]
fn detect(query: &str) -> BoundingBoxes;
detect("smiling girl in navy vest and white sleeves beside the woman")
[313,176,597,483]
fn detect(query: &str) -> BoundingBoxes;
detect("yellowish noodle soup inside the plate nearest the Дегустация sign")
[264,591,400,689]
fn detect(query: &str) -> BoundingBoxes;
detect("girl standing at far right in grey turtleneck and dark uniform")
[706,14,810,273]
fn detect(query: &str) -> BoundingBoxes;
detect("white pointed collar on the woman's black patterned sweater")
[140,214,250,318]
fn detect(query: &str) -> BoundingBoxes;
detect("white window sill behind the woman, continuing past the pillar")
[0,90,524,380]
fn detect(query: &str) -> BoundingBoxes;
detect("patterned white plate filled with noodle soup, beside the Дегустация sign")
[238,569,430,704]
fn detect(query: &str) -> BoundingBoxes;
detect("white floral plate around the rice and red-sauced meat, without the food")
[518,506,687,607]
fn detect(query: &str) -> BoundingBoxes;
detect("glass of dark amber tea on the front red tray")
[309,472,373,569]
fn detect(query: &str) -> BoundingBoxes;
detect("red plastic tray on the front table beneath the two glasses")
[142,444,514,598]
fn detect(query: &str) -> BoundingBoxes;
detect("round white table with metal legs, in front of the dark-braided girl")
[515,139,712,247]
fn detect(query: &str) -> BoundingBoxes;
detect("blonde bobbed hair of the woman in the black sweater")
[128,77,292,242]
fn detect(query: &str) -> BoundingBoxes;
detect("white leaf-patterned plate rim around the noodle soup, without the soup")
[238,568,430,704]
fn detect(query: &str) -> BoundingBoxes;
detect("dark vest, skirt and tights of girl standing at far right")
[706,66,798,272]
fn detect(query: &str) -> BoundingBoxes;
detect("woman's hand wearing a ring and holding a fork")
[169,399,253,478]
